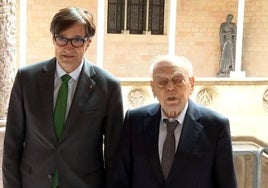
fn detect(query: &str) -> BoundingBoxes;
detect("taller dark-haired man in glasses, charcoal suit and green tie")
[2,8,123,188]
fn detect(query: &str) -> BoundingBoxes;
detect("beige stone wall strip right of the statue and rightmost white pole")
[242,0,268,77]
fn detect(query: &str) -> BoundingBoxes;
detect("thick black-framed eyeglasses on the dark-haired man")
[54,35,87,48]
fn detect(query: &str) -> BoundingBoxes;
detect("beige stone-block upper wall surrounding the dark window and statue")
[14,0,268,77]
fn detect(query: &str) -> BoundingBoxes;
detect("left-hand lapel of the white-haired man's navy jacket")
[143,104,164,183]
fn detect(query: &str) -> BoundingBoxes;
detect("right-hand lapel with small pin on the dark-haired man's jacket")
[59,60,96,142]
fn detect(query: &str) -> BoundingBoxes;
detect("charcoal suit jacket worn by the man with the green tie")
[2,58,123,188]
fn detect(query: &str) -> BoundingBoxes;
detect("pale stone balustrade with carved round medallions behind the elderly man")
[121,78,268,145]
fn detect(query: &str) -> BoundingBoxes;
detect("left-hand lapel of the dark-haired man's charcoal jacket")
[37,58,57,144]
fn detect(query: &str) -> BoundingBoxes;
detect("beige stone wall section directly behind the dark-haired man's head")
[17,0,97,67]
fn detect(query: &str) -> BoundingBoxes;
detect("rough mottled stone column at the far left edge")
[0,0,16,120]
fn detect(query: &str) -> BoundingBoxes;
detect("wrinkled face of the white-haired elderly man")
[150,62,194,118]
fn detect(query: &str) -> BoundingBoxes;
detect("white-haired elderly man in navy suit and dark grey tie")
[111,55,237,188]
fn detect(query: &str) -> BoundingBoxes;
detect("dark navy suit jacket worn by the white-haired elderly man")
[111,100,236,188]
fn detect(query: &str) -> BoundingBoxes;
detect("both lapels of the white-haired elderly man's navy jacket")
[143,100,203,184]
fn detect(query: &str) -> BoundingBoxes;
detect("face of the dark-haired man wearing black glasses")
[53,24,91,72]
